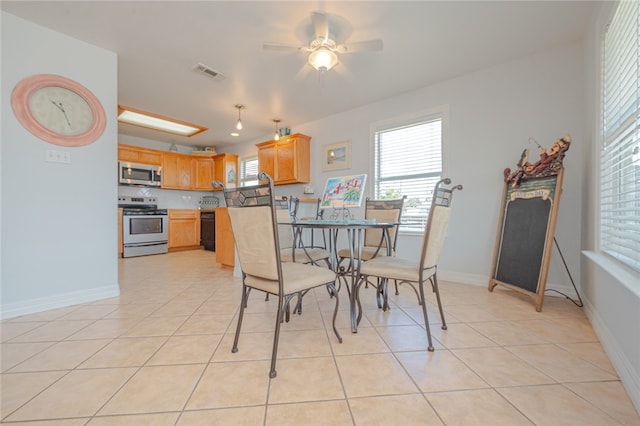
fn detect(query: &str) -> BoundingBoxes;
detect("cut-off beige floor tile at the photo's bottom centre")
[265,400,353,426]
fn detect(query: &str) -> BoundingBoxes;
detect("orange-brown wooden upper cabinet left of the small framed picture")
[256,133,311,185]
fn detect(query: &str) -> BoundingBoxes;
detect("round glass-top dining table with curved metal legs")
[280,219,398,333]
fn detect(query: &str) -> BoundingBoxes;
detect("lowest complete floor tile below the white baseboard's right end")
[99,364,205,415]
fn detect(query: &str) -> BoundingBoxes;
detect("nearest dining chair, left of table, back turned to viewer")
[215,173,342,378]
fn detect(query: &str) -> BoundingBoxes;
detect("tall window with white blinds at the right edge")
[600,1,640,271]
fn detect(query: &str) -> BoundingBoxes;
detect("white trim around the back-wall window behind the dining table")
[367,104,449,236]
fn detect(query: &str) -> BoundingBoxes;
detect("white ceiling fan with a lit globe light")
[262,12,382,73]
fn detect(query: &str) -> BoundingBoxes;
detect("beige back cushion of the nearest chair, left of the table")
[228,205,278,287]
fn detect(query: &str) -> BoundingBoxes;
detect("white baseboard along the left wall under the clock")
[0,284,120,319]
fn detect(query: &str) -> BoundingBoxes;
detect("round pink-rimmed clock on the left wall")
[11,74,107,146]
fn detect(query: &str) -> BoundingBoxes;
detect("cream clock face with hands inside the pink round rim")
[29,86,93,135]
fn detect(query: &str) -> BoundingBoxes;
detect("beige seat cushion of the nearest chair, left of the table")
[244,262,336,294]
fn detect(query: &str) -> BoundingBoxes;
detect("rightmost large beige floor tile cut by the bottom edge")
[497,385,618,426]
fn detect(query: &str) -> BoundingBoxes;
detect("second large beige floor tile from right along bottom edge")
[425,389,536,426]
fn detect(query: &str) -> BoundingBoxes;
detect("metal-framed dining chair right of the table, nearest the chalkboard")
[355,178,462,351]
